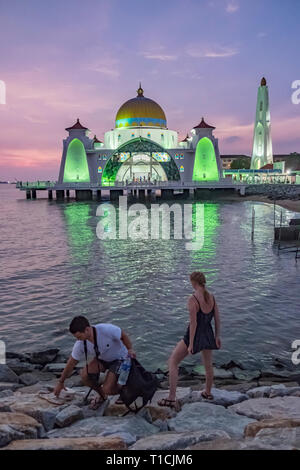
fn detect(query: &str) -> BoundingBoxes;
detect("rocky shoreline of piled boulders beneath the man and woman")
[0,349,300,450]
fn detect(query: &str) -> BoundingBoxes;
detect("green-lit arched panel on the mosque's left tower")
[63,139,90,183]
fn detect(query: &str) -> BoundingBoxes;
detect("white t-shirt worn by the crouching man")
[71,323,127,362]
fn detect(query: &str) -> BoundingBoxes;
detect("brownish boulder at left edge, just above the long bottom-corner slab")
[0,412,43,447]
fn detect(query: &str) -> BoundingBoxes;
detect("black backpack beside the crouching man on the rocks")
[120,358,159,416]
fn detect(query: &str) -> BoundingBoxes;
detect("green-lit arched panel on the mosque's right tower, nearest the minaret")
[193,137,219,181]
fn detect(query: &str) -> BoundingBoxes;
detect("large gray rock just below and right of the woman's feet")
[168,402,254,437]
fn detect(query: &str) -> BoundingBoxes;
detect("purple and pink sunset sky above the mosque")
[0,0,300,181]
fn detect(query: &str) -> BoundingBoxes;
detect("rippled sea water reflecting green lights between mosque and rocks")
[0,185,300,368]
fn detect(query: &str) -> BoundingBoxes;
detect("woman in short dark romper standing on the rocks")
[158,272,221,411]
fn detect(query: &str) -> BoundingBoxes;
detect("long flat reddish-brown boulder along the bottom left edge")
[3,436,127,450]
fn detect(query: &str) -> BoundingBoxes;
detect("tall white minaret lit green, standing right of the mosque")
[251,77,273,170]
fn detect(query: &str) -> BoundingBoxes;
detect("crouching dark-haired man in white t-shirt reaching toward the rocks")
[54,316,136,409]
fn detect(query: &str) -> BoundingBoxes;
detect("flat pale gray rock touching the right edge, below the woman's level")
[228,396,300,420]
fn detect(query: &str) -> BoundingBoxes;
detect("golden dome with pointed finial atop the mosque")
[116,84,167,129]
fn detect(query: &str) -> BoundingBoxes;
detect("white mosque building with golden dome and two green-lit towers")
[58,84,223,187]
